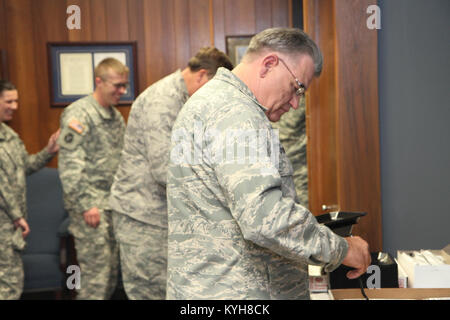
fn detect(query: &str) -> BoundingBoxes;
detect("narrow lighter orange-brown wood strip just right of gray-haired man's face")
[304,1,338,214]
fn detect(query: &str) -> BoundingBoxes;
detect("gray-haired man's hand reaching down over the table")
[342,237,372,279]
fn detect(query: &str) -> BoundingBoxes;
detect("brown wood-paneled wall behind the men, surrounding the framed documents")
[0,0,292,167]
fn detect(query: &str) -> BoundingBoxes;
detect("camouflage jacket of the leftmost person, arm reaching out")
[0,123,53,225]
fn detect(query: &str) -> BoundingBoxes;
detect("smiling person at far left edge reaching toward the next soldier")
[0,80,59,300]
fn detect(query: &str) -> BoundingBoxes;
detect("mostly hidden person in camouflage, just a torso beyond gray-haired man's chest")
[272,97,308,208]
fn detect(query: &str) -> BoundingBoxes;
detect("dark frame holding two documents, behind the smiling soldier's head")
[47,42,138,107]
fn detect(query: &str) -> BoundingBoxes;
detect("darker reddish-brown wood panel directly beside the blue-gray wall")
[335,0,382,251]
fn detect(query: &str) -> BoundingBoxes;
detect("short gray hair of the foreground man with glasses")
[245,28,323,77]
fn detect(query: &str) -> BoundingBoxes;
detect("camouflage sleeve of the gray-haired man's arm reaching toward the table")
[213,112,348,271]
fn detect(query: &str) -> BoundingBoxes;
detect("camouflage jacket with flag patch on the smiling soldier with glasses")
[58,95,125,232]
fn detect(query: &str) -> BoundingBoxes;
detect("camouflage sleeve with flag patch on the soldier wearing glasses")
[58,110,95,214]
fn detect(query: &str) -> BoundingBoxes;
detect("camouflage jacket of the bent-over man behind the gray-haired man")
[110,70,189,225]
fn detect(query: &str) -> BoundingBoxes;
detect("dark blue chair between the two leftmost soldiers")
[22,168,68,299]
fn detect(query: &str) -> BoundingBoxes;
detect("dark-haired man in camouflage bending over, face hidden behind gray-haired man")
[110,47,232,300]
